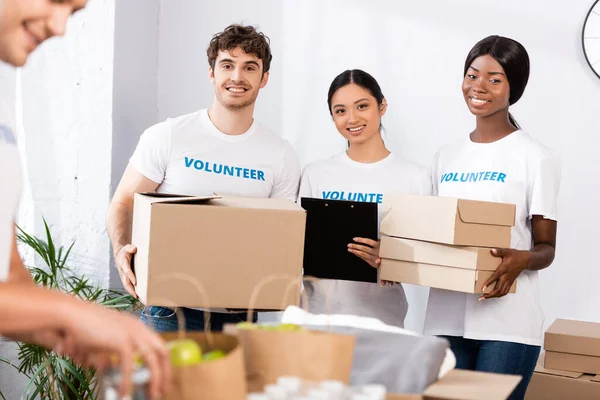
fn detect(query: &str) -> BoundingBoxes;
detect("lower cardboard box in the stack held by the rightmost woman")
[379,236,516,293]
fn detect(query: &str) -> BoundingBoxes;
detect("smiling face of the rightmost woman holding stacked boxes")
[462,55,510,117]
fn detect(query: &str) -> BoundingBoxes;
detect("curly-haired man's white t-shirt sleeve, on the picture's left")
[129,121,171,184]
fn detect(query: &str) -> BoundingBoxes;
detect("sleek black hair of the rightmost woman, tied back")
[463,35,529,129]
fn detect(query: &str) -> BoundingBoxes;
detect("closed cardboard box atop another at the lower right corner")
[544,319,600,374]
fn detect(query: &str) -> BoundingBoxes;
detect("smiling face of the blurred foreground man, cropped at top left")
[0,0,87,67]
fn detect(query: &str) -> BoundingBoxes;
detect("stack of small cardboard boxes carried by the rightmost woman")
[379,194,516,293]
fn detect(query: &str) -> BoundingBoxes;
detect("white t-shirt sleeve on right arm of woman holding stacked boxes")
[529,155,561,221]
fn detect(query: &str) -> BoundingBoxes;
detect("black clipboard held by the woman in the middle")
[300,197,378,283]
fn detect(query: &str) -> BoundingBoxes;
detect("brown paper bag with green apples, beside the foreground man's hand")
[161,332,248,400]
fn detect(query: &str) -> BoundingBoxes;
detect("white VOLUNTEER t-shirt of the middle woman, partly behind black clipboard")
[299,152,431,327]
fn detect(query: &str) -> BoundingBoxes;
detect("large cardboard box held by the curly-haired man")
[132,194,306,310]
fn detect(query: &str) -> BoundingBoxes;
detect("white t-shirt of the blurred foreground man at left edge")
[0,100,21,282]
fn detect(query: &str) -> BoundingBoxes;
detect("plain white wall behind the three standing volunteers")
[158,0,600,329]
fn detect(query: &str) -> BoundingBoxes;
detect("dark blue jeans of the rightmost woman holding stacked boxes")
[443,336,540,400]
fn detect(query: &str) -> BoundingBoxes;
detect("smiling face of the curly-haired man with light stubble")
[209,47,269,110]
